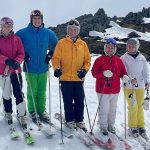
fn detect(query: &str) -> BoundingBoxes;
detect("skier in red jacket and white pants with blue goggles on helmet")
[92,38,129,135]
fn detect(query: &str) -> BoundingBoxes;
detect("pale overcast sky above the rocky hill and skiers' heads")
[0,0,150,30]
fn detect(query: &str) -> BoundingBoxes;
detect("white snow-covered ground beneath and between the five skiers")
[0,57,150,150]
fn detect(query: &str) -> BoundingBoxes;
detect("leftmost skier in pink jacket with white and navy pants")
[0,17,27,127]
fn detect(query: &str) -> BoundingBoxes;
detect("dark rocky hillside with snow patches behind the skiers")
[50,7,150,60]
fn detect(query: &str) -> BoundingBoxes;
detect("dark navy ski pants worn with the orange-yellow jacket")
[61,81,84,122]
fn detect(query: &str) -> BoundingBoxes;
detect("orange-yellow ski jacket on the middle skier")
[52,36,91,81]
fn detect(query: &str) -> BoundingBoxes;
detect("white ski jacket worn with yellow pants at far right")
[121,52,150,89]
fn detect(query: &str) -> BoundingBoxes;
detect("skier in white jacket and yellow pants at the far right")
[121,38,150,137]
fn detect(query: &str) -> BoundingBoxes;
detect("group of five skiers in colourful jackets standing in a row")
[0,10,150,138]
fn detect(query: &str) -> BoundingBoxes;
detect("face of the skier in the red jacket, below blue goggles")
[105,43,116,57]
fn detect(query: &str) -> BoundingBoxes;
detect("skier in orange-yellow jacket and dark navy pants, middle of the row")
[52,20,91,130]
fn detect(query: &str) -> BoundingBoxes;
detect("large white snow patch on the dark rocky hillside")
[89,21,150,41]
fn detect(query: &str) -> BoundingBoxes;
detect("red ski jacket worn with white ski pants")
[92,56,127,94]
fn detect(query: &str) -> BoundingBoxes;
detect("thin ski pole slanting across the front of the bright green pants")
[24,62,41,130]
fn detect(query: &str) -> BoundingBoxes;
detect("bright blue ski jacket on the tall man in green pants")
[16,23,58,74]
